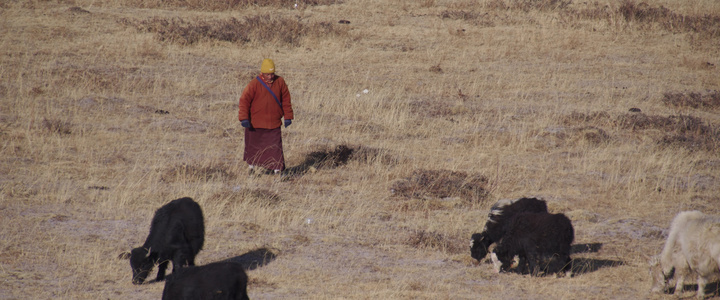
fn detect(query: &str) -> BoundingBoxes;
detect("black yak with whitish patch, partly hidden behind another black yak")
[470,198,547,261]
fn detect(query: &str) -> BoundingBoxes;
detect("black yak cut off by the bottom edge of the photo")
[162,261,250,300]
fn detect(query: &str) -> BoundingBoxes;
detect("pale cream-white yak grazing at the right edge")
[650,211,720,299]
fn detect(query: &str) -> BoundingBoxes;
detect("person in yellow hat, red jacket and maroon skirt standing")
[238,59,293,174]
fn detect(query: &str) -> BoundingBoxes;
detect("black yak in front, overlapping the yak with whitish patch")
[492,213,575,275]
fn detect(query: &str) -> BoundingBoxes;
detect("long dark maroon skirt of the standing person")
[243,127,285,170]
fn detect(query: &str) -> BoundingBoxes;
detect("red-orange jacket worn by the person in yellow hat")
[238,76,293,129]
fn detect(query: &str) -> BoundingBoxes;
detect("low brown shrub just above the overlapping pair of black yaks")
[391,170,489,203]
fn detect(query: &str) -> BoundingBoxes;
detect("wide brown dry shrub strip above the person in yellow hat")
[120,15,347,46]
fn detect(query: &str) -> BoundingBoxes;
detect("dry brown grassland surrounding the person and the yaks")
[0,0,720,299]
